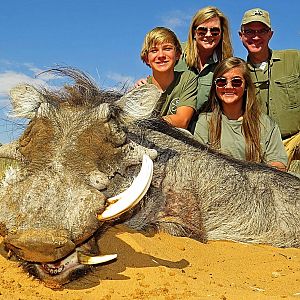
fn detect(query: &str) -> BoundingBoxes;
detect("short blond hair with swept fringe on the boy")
[141,27,182,64]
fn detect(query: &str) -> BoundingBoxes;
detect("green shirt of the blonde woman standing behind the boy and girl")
[175,43,219,112]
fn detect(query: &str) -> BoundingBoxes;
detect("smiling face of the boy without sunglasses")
[146,42,180,73]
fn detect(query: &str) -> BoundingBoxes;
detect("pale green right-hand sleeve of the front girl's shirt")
[265,122,288,166]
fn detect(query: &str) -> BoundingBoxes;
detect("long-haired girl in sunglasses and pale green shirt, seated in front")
[194,57,287,171]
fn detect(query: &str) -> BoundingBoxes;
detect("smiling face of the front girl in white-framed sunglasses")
[216,67,246,115]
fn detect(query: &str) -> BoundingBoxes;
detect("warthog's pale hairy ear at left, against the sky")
[10,84,46,119]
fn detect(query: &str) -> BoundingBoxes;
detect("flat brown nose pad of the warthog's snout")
[5,229,75,262]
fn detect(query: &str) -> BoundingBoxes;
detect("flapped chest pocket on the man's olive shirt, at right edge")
[275,74,300,109]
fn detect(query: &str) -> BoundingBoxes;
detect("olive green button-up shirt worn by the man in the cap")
[248,49,300,138]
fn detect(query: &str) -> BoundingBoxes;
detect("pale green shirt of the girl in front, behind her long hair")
[194,113,287,166]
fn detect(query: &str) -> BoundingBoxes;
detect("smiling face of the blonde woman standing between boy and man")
[194,17,222,55]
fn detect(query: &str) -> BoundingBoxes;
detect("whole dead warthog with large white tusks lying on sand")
[0,68,300,287]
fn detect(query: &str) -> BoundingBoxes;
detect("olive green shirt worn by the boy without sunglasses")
[147,71,197,116]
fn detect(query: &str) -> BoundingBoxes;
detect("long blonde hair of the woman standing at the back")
[184,6,233,68]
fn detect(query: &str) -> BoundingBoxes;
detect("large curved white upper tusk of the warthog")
[97,154,153,221]
